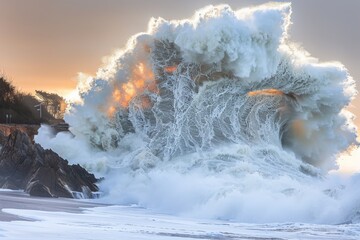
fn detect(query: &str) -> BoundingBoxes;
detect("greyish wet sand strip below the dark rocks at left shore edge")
[0,190,104,222]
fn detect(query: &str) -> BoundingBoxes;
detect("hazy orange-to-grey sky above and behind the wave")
[0,0,360,172]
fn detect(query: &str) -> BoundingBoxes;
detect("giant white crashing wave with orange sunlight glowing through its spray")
[36,3,360,223]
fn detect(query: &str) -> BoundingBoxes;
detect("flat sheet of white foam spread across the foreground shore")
[0,206,360,240]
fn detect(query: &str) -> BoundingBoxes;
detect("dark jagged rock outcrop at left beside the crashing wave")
[0,130,98,198]
